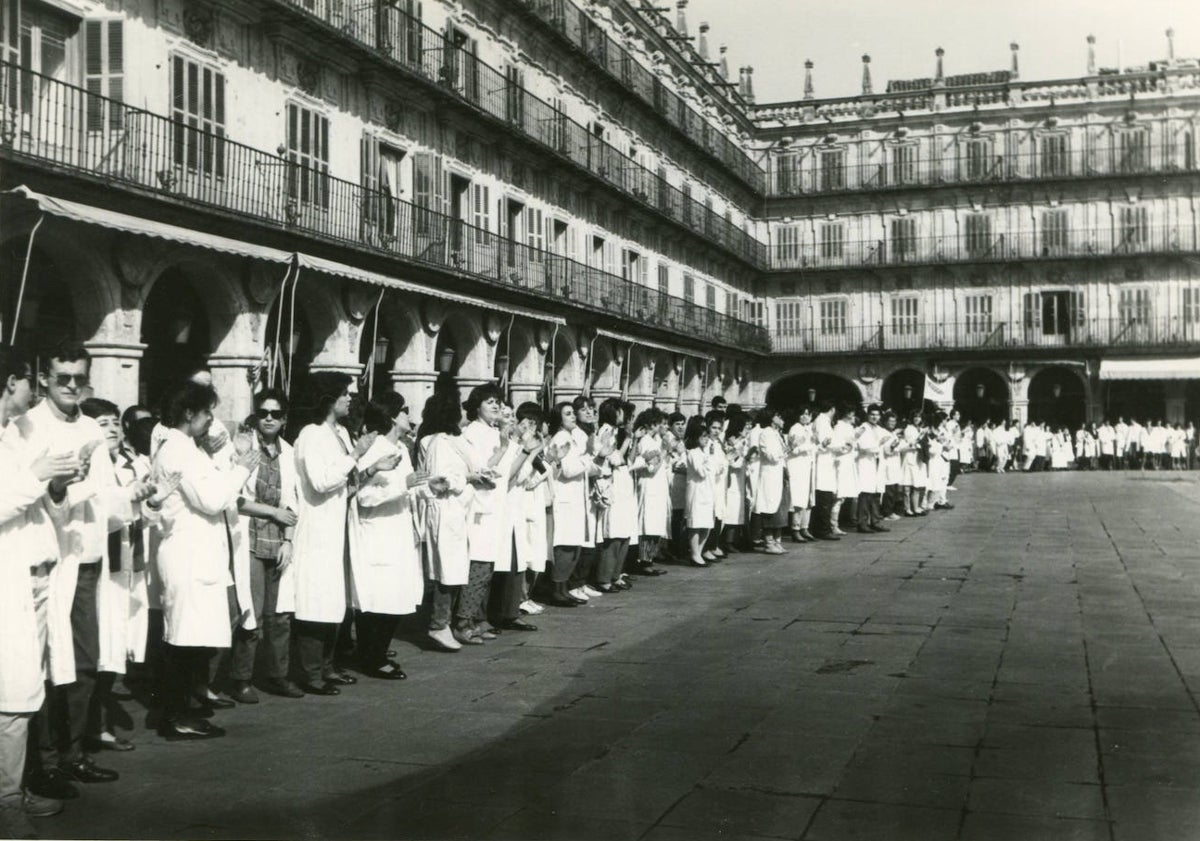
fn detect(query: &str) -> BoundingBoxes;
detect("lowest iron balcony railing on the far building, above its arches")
[772,312,1200,354]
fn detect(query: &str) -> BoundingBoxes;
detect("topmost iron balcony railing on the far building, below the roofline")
[768,134,1200,198]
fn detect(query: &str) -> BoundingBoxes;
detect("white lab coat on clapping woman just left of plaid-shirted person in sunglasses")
[154,429,248,648]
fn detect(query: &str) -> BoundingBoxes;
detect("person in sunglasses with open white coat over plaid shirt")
[229,389,304,704]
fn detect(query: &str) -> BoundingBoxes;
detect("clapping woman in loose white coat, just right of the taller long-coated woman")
[349,391,425,680]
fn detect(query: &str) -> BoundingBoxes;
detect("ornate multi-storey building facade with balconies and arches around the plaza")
[0,0,1200,422]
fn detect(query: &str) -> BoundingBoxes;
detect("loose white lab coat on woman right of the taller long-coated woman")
[349,435,425,615]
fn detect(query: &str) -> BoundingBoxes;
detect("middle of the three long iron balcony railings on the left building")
[268,0,766,268]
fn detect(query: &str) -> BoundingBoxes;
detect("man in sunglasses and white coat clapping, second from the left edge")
[26,342,119,798]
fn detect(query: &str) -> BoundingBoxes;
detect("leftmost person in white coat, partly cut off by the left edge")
[0,348,79,837]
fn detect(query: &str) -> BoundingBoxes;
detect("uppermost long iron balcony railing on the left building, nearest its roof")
[520,0,766,193]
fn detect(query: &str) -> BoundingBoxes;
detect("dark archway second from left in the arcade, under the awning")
[138,269,212,407]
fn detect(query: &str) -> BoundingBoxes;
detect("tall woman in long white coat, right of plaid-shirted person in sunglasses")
[292,371,376,695]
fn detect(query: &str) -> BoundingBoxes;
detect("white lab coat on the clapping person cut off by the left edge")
[0,419,76,713]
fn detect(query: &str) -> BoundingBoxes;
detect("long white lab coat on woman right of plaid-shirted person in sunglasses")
[292,423,354,623]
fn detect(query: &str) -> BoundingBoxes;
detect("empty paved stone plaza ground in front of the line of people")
[51,473,1200,841]
